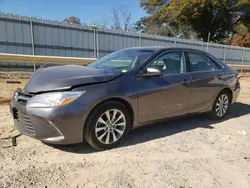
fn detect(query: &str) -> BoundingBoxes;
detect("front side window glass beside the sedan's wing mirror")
[149,51,185,75]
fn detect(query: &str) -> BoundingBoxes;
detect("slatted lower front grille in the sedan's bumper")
[13,109,35,136]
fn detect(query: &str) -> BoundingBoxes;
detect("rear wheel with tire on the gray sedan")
[208,91,231,120]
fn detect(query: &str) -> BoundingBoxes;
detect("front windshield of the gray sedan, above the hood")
[88,49,154,72]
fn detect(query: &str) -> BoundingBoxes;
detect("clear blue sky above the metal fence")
[0,0,145,24]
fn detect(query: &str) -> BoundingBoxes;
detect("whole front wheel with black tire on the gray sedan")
[84,101,132,150]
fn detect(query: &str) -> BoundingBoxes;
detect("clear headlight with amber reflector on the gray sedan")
[28,91,86,108]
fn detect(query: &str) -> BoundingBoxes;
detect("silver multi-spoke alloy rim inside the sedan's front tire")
[95,109,126,144]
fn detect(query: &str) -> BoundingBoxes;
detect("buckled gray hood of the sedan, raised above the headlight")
[24,65,121,93]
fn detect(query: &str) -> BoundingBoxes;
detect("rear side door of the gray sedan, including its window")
[185,51,223,113]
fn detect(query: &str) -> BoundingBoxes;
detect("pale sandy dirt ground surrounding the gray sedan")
[0,72,250,188]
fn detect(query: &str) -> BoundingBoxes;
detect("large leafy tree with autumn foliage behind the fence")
[137,0,250,41]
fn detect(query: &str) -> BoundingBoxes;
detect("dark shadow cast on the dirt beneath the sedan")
[50,103,250,154]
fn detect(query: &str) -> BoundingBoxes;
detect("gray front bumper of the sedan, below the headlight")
[10,94,90,144]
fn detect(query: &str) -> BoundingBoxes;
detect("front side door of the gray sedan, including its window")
[137,51,191,123]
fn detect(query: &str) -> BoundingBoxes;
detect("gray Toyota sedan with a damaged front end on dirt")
[10,47,240,150]
